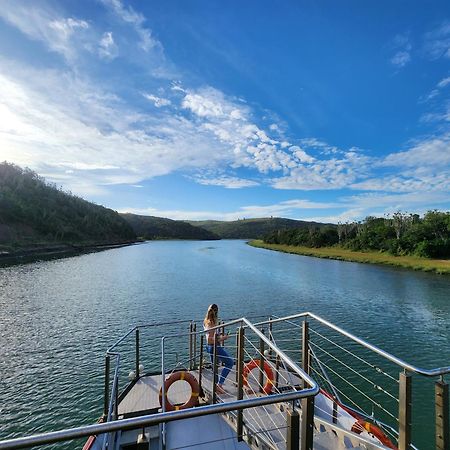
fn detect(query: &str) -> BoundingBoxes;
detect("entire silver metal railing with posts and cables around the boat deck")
[0,312,450,450]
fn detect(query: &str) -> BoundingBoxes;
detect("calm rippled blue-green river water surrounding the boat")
[0,241,450,448]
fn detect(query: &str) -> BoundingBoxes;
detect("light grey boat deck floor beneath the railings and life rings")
[119,368,385,450]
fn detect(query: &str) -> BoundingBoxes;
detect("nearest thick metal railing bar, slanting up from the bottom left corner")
[0,385,319,450]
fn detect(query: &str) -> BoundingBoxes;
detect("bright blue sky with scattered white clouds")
[0,0,450,222]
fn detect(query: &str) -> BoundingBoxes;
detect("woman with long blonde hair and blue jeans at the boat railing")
[203,304,233,394]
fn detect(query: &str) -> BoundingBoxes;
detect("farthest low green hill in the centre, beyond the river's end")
[188,217,325,239]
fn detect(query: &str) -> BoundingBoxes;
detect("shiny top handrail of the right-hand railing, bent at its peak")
[254,312,450,377]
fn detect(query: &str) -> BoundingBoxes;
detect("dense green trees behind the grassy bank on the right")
[264,210,450,258]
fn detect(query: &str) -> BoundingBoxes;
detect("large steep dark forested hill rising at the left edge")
[0,162,136,252]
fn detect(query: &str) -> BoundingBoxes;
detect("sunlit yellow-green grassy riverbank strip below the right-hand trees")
[248,240,450,275]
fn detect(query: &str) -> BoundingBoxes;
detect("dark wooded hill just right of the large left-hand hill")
[121,214,220,240]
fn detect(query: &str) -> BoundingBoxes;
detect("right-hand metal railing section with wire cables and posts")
[255,312,450,450]
